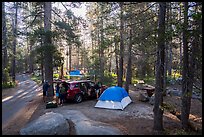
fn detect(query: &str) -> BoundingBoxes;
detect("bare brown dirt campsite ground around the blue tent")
[2,83,202,135]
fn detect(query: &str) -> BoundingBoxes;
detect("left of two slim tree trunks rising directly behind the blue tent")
[118,2,124,87]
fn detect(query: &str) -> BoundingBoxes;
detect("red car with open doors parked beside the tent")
[54,80,103,103]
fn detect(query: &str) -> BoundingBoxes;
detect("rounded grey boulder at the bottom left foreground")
[20,112,69,135]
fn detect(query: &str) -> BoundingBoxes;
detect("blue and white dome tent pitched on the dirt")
[95,86,132,110]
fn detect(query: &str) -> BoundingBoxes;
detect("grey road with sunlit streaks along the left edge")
[2,74,42,130]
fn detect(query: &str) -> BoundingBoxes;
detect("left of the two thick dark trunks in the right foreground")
[153,2,166,131]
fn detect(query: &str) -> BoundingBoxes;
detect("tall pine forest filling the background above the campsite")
[2,2,202,131]
